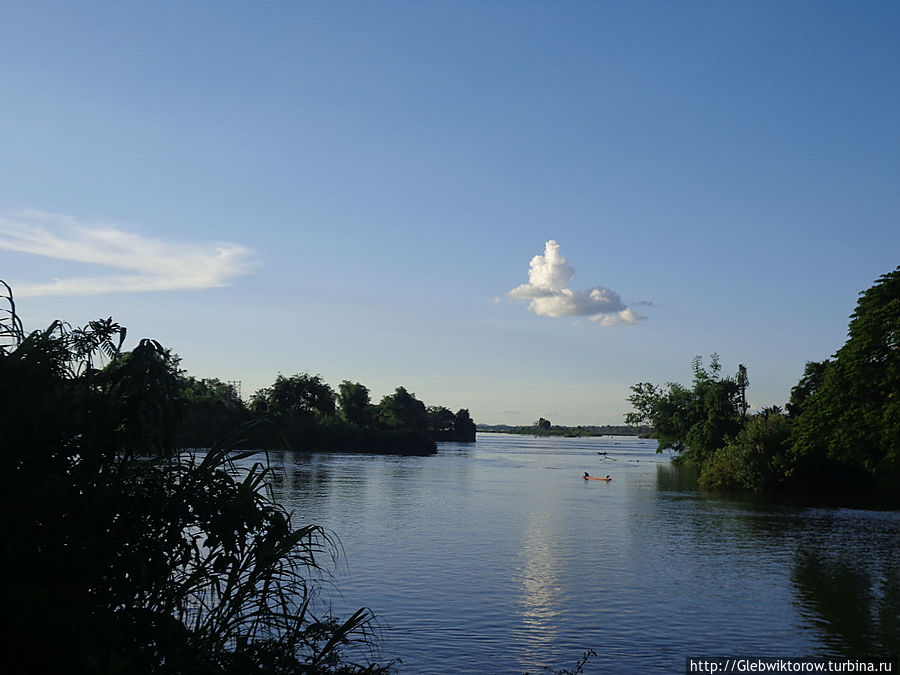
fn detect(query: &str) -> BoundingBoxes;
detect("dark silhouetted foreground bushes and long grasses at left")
[0,287,393,674]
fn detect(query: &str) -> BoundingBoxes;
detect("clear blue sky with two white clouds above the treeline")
[0,0,900,424]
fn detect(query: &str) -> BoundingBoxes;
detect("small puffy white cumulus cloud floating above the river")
[509,239,646,326]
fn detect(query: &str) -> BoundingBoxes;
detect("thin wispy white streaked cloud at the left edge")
[0,211,253,297]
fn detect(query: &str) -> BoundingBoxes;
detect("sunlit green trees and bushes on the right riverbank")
[626,267,900,498]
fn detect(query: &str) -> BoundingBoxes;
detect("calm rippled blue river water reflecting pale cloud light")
[272,434,900,674]
